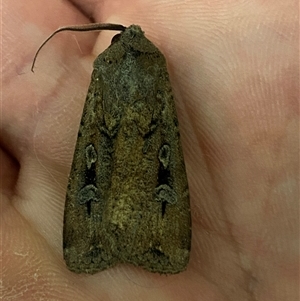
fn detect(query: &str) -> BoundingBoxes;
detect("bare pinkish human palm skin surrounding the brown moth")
[0,0,299,301]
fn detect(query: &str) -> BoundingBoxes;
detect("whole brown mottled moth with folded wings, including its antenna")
[33,24,191,274]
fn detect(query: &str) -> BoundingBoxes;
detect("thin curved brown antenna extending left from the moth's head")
[31,23,126,72]
